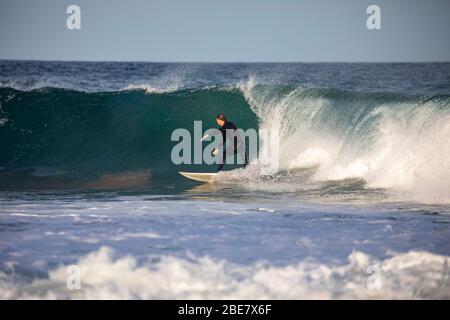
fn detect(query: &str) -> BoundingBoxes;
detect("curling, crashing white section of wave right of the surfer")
[238,77,450,202]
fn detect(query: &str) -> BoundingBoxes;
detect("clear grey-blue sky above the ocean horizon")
[0,0,450,62]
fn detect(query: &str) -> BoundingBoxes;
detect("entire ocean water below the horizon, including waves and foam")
[0,61,450,299]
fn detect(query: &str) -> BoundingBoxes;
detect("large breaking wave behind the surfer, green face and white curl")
[0,77,450,203]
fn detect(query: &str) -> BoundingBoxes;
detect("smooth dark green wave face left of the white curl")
[0,88,257,188]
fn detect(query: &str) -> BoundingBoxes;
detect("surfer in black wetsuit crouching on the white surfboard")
[212,112,248,172]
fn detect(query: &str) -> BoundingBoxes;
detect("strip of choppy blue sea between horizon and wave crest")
[0,60,450,95]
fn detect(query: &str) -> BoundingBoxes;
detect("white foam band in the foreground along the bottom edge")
[0,247,450,299]
